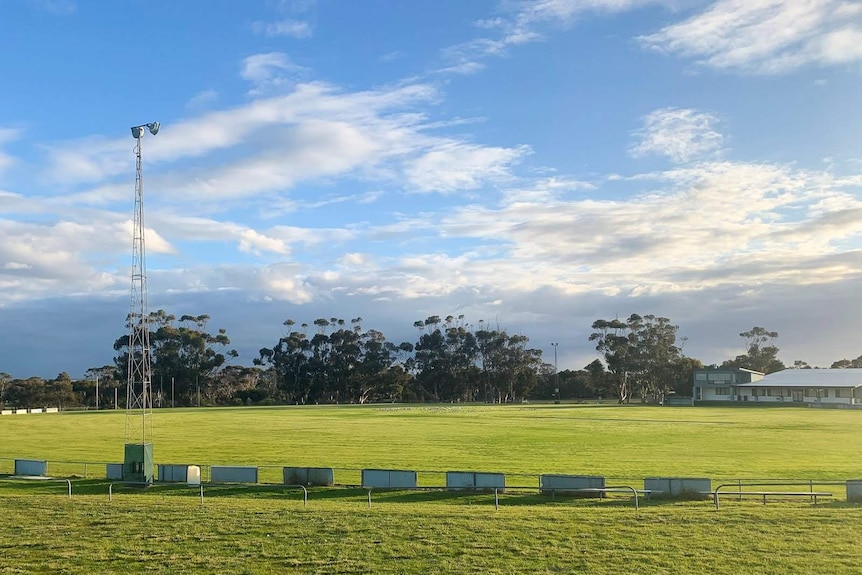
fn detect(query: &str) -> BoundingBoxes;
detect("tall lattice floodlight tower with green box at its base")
[123,122,159,484]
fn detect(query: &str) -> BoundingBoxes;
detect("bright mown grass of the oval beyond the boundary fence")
[0,405,862,481]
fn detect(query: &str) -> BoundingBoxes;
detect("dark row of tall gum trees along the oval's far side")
[0,310,862,409]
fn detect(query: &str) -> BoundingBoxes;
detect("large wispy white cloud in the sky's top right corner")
[641,0,862,74]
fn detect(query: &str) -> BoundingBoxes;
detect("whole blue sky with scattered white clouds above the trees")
[0,0,862,377]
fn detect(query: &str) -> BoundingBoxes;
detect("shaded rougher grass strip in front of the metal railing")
[0,487,862,575]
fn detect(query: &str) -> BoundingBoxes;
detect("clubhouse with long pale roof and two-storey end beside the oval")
[693,368,862,406]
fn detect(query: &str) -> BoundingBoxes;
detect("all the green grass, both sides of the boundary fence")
[0,405,862,575]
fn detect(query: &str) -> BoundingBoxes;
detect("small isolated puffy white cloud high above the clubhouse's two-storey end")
[629,108,724,162]
